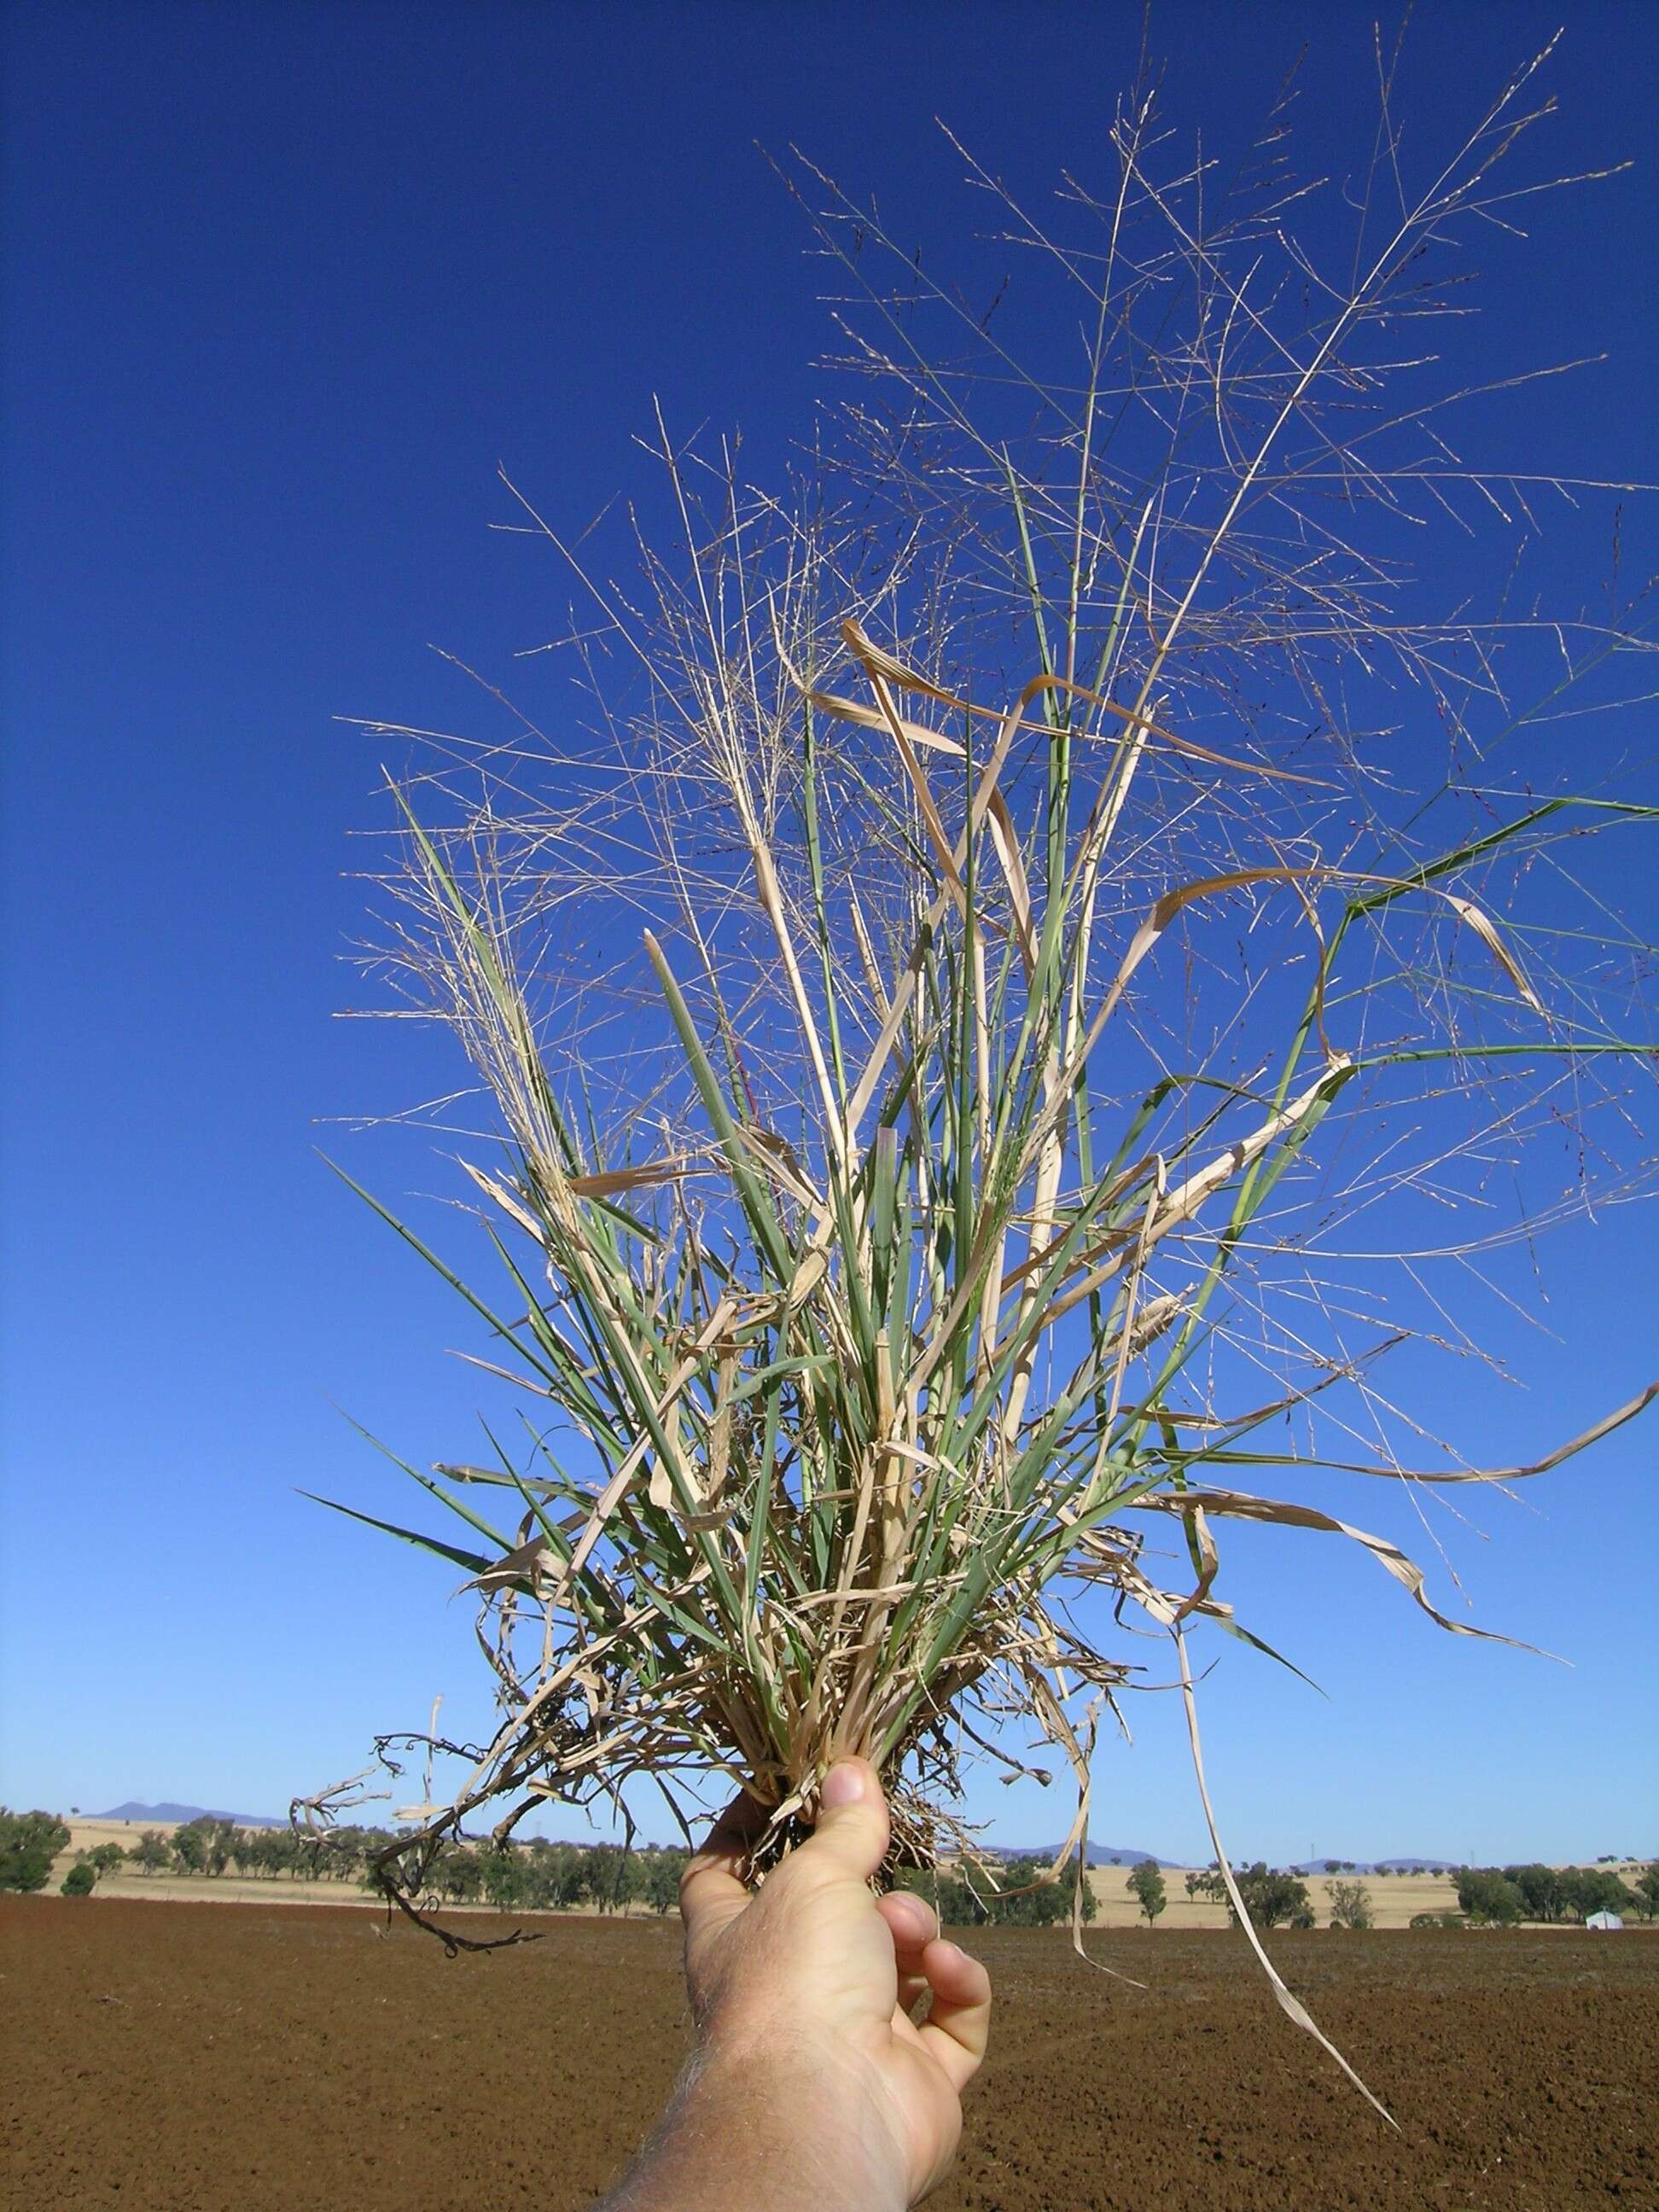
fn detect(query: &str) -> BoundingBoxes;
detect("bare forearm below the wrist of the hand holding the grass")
[595,2051,907,2212]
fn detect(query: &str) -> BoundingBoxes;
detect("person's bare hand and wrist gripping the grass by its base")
[608,1759,991,2212]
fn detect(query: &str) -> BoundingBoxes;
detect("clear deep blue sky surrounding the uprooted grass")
[0,0,1659,1858]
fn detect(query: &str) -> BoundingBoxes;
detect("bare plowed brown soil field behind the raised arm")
[0,1898,1659,2212]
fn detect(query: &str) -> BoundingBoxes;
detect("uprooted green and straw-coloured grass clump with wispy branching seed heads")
[305,30,1655,2105]
